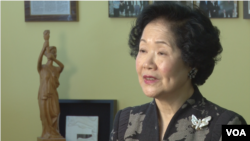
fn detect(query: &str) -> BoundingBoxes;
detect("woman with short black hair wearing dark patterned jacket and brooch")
[110,3,246,141]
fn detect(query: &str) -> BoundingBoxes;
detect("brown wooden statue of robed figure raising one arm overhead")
[37,30,65,141]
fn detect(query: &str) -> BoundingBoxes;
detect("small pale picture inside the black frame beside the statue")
[66,116,98,141]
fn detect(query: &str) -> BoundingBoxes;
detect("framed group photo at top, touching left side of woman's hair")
[108,0,149,18]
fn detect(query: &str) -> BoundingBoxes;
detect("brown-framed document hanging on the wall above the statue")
[24,0,78,22]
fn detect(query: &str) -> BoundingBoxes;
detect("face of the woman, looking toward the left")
[136,19,191,98]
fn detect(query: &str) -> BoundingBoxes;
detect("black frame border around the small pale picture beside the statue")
[59,99,117,141]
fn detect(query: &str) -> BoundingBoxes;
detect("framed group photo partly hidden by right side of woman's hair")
[196,0,238,18]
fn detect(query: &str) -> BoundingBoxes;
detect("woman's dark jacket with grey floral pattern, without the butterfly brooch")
[110,87,247,141]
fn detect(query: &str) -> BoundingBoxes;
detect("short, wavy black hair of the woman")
[128,2,223,85]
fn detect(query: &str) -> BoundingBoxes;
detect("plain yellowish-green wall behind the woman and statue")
[0,1,250,141]
